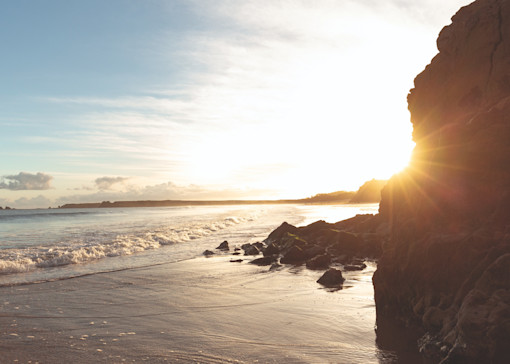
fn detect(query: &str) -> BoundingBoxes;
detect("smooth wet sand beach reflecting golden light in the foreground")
[0,256,394,363]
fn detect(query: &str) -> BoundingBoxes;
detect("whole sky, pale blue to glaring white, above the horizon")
[0,0,471,208]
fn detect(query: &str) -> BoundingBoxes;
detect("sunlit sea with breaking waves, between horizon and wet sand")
[0,204,378,286]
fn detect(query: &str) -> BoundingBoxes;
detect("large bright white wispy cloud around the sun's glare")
[10,0,469,199]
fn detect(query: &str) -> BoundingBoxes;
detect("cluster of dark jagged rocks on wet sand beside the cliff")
[204,215,388,288]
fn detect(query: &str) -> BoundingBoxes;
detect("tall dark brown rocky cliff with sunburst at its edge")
[374,0,510,363]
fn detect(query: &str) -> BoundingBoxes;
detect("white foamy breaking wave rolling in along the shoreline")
[0,217,253,274]
